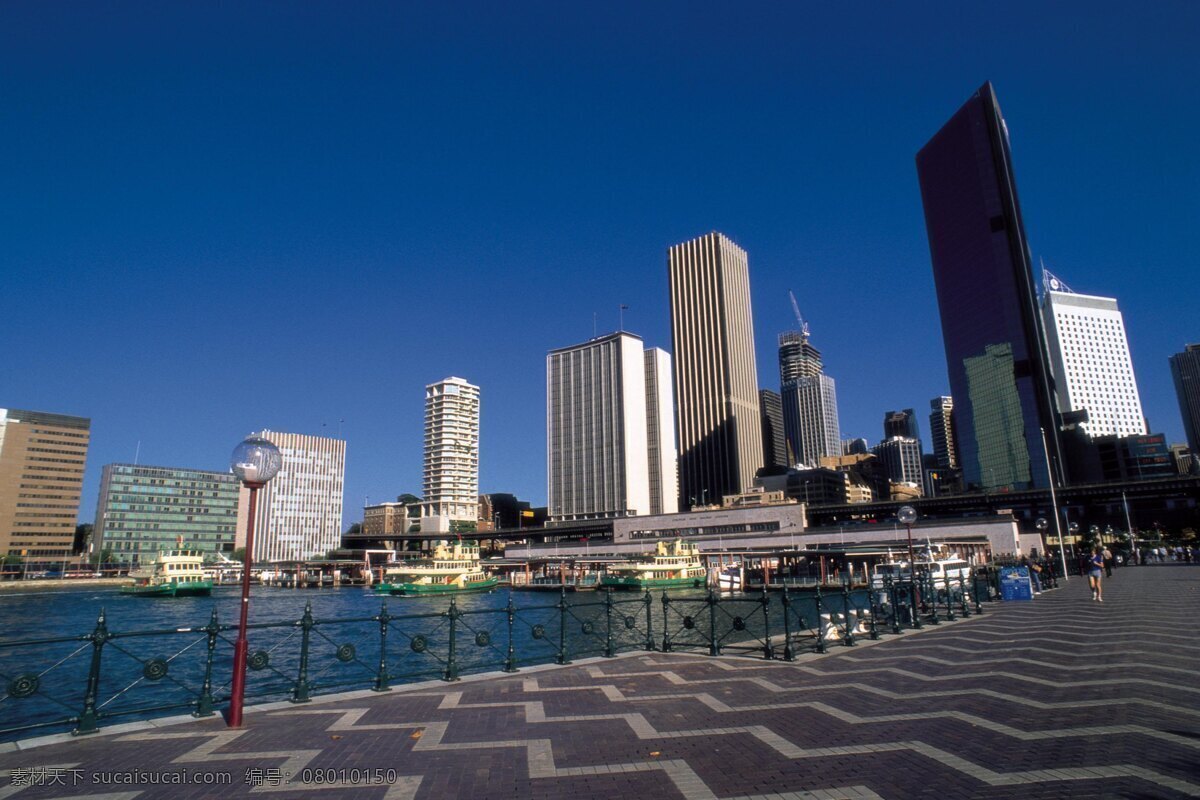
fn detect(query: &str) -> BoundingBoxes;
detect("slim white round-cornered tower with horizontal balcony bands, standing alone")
[421,378,479,533]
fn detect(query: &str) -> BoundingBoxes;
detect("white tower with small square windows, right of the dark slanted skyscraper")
[1042,272,1146,437]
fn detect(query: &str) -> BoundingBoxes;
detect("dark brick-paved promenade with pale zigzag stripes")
[0,565,1200,800]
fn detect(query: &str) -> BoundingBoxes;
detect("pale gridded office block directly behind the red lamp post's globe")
[243,431,346,561]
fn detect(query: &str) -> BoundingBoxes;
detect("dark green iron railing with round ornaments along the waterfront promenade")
[0,572,998,739]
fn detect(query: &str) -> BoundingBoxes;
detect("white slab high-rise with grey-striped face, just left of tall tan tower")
[546,332,677,522]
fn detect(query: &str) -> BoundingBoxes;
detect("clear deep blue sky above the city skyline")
[0,1,1200,523]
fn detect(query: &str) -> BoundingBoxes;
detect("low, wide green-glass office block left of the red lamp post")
[92,464,241,565]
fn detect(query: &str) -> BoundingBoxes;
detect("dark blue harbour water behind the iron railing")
[0,587,779,739]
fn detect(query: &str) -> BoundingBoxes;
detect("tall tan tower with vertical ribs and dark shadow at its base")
[667,231,762,504]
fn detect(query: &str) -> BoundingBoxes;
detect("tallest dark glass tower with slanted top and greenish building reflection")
[917,83,1063,489]
